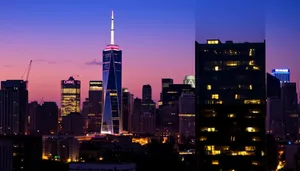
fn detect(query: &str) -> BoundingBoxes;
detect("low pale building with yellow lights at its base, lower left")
[43,135,80,162]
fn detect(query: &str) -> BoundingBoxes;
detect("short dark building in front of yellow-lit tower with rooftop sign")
[62,112,88,136]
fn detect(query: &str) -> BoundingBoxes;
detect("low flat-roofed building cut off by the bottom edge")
[69,163,136,171]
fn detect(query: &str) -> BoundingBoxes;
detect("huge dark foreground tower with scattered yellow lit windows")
[195,40,266,171]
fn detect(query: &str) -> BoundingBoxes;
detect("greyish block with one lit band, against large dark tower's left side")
[179,93,195,142]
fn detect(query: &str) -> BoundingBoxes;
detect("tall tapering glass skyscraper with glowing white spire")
[101,11,122,134]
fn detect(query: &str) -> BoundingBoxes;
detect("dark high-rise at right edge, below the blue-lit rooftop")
[281,82,299,140]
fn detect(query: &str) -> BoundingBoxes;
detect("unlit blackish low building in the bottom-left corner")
[0,135,42,171]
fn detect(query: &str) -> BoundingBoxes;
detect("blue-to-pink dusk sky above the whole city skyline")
[0,0,300,103]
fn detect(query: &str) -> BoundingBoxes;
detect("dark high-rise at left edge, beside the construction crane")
[0,80,28,135]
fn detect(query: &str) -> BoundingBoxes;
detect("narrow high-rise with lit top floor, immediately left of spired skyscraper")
[88,81,103,133]
